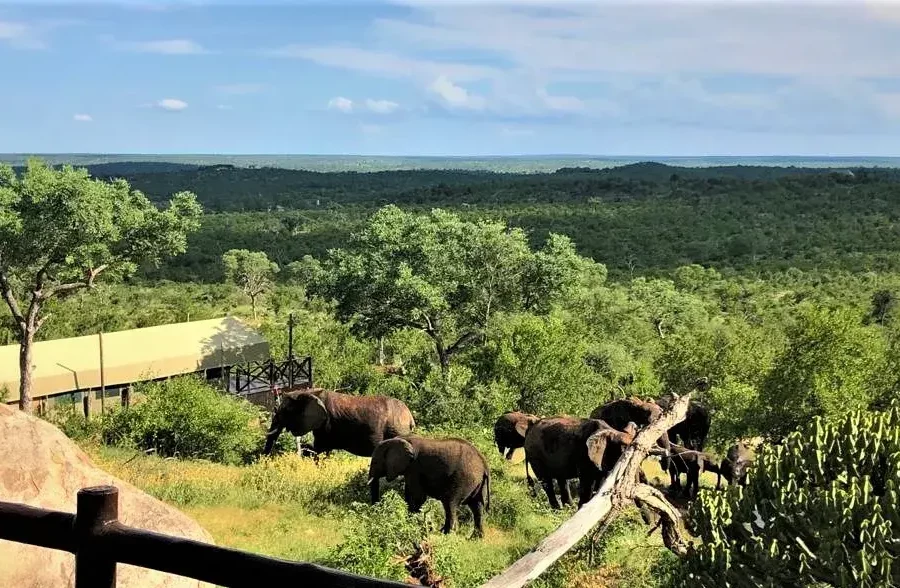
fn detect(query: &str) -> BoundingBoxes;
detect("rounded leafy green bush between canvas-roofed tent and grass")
[103,376,262,463]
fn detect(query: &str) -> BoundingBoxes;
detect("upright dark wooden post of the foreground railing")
[75,486,119,588]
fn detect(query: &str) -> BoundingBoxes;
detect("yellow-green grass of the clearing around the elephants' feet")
[85,439,684,587]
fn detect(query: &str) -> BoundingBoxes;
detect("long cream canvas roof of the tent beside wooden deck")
[0,317,269,402]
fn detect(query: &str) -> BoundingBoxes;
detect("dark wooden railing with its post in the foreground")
[0,486,408,588]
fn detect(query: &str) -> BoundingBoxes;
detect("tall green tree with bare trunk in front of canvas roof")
[0,159,202,412]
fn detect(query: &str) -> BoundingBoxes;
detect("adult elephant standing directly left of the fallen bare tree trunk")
[525,417,636,509]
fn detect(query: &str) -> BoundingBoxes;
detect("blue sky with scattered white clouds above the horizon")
[0,0,900,156]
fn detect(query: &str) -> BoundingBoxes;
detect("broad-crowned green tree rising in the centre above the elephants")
[317,205,589,377]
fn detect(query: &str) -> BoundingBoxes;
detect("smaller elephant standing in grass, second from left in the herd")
[369,435,491,537]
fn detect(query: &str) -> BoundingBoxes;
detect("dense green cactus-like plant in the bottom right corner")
[675,403,900,588]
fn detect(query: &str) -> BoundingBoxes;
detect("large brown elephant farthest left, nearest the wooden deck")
[263,389,415,457]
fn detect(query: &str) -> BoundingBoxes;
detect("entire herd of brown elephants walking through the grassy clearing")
[263,389,751,537]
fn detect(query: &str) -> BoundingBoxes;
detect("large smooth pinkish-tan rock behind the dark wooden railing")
[0,404,213,588]
